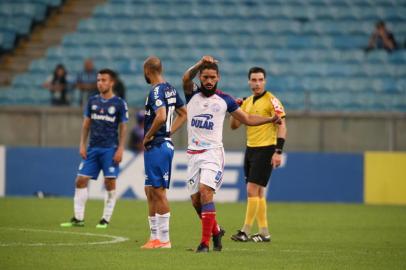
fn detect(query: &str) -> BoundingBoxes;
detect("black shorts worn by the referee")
[244,145,275,187]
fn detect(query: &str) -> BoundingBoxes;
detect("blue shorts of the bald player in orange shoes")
[144,141,174,188]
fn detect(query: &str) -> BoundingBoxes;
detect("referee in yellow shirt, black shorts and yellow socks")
[231,67,286,242]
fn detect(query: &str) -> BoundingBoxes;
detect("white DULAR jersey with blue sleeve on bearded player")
[186,87,239,150]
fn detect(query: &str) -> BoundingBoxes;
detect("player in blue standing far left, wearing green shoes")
[61,69,128,229]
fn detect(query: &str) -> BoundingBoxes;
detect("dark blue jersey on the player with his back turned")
[144,82,184,145]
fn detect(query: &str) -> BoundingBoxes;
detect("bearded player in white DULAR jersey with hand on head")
[183,56,280,252]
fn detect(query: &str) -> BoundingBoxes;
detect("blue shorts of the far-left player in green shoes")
[78,147,120,180]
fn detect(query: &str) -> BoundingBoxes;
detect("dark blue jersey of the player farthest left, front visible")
[84,95,128,148]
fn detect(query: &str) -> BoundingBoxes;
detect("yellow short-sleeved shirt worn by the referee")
[241,91,285,147]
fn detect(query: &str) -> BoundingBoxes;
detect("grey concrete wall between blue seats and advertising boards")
[0,107,406,152]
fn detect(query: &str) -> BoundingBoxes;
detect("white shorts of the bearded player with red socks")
[187,147,224,195]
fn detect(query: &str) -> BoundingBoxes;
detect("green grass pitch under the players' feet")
[0,198,406,270]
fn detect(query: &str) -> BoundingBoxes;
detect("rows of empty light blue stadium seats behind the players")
[0,0,406,112]
